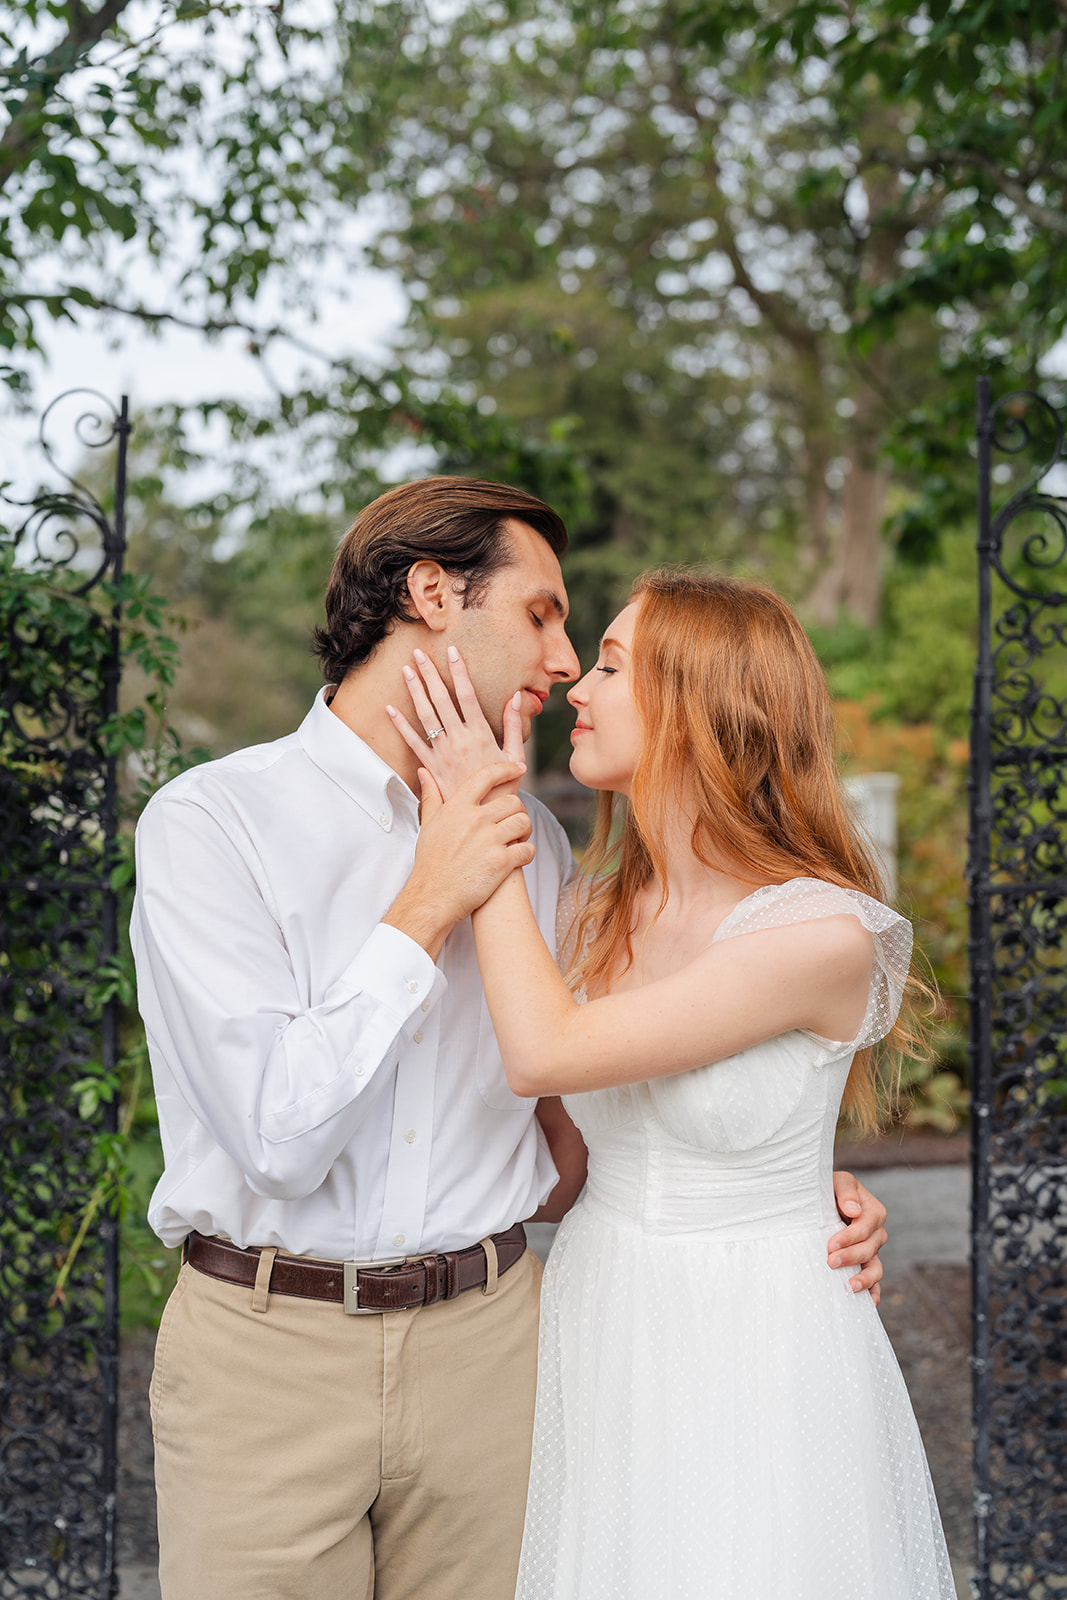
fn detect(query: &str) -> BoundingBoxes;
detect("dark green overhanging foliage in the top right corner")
[688,0,1067,562]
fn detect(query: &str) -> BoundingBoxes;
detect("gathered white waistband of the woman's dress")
[584,1150,841,1243]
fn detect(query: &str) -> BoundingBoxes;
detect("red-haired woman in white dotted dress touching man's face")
[388,571,955,1600]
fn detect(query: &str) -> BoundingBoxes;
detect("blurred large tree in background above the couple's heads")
[316,0,933,621]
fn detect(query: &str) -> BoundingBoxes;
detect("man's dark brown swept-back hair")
[315,478,566,683]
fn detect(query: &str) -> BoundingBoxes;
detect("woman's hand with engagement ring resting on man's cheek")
[386,645,523,800]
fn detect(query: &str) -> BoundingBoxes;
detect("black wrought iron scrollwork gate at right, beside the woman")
[969,379,1067,1600]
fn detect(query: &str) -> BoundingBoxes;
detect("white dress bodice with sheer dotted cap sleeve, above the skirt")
[565,878,912,1240]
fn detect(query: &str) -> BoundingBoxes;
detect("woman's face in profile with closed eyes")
[566,603,645,795]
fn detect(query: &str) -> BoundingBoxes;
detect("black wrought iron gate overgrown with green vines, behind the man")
[0,390,130,1600]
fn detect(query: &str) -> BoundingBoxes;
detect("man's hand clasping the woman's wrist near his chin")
[382,762,534,960]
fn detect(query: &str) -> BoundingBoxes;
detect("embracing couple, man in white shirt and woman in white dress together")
[133,478,953,1600]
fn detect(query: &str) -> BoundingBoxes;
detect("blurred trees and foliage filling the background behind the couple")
[0,0,1067,1318]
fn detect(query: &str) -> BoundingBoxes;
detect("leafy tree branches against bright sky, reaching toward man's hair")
[0,0,591,604]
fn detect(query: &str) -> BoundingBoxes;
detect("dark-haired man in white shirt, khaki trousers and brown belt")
[133,478,885,1600]
